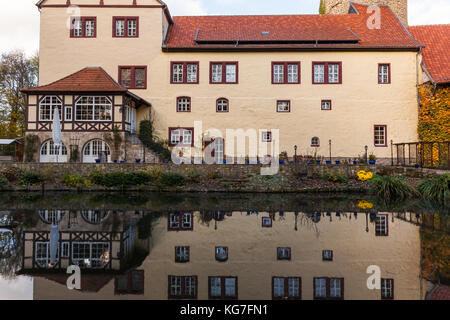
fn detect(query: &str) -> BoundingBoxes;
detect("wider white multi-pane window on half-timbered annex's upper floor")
[75,96,112,121]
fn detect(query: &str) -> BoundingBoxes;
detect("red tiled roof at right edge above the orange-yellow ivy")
[408,24,450,83]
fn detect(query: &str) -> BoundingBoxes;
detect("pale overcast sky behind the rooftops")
[0,0,450,54]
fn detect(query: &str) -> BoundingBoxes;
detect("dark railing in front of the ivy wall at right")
[393,141,450,170]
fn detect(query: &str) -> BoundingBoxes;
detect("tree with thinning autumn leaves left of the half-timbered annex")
[0,51,39,138]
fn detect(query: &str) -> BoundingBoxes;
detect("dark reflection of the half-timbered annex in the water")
[21,210,149,293]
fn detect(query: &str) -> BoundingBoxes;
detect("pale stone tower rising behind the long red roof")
[324,0,408,26]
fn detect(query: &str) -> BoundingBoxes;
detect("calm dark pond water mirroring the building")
[0,193,450,300]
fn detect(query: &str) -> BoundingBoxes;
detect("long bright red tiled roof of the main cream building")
[164,3,421,51]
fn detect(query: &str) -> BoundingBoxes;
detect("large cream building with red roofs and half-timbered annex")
[24,0,422,163]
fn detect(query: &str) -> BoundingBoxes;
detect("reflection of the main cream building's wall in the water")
[29,212,423,300]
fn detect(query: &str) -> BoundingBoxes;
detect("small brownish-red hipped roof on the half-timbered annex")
[22,67,127,92]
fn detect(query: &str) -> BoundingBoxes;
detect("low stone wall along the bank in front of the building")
[0,163,442,179]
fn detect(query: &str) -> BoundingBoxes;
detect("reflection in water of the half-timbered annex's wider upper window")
[72,242,110,269]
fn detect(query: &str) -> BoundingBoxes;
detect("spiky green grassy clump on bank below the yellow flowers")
[369,175,419,201]
